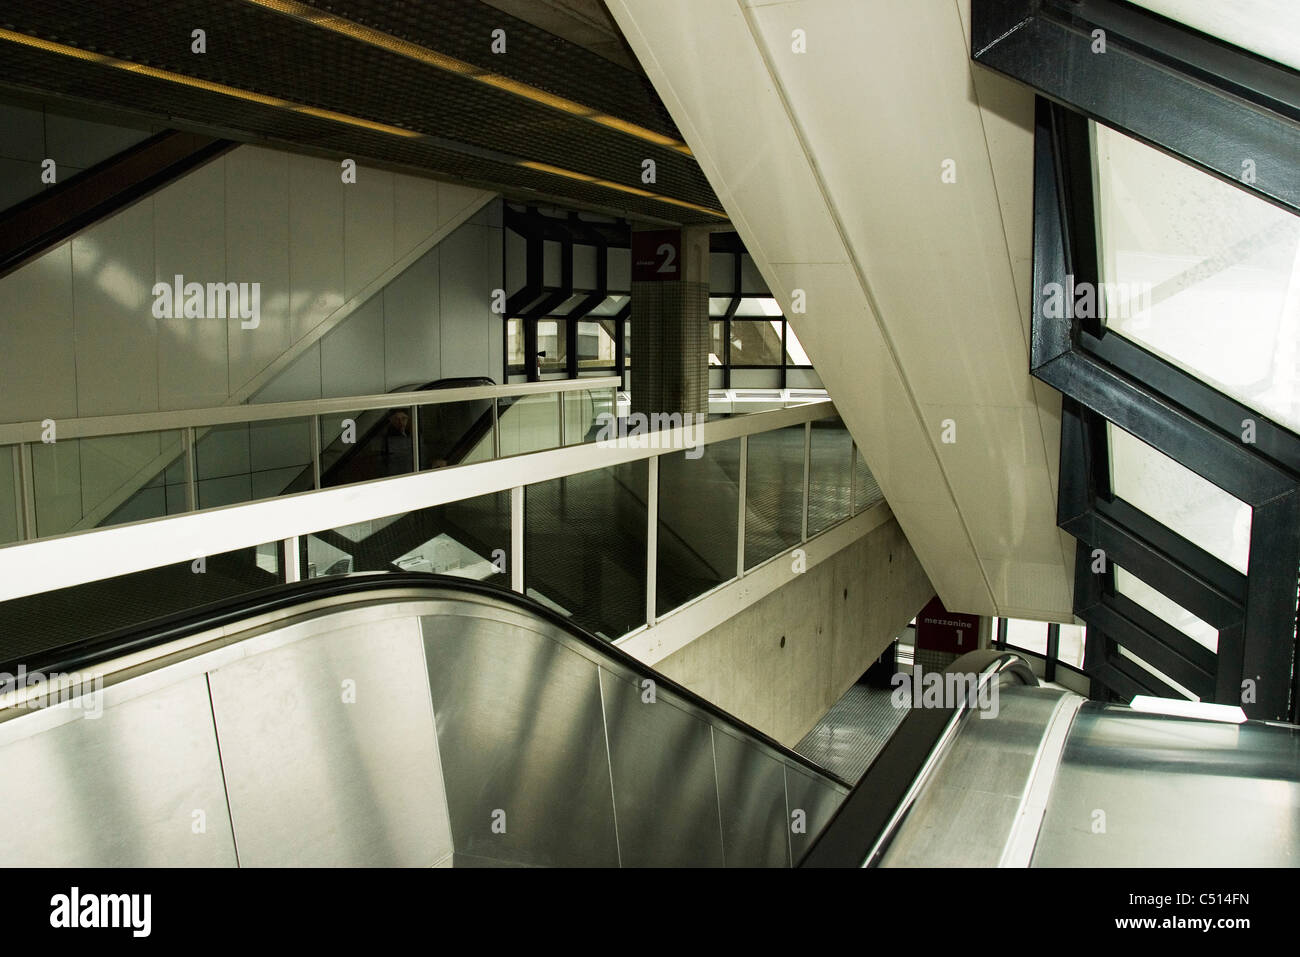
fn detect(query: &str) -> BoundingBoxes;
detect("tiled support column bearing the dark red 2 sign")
[631,228,709,415]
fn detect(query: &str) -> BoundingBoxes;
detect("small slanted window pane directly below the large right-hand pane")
[1106,423,1251,572]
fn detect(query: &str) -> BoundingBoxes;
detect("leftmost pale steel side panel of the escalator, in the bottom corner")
[0,675,235,867]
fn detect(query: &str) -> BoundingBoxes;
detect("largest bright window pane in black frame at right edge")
[1093,125,1300,430]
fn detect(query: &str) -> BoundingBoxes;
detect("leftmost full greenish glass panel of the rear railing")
[32,430,186,537]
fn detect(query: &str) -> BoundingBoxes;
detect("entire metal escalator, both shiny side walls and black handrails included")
[0,573,1300,867]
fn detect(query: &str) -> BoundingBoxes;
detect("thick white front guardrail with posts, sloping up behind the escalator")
[0,400,878,627]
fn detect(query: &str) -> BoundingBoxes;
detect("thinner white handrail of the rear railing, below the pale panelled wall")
[0,376,621,446]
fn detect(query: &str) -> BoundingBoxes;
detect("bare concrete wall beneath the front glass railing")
[655,519,935,746]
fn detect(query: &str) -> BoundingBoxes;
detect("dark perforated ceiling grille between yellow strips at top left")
[0,0,720,222]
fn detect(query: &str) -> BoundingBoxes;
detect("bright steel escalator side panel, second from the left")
[208,610,451,867]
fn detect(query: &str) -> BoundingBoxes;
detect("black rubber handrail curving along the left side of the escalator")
[12,572,852,791]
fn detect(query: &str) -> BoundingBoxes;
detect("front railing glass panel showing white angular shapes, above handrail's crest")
[299,492,510,588]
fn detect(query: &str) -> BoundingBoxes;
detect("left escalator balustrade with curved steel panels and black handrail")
[0,573,849,866]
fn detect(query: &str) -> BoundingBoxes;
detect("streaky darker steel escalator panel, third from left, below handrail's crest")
[420,614,619,867]
